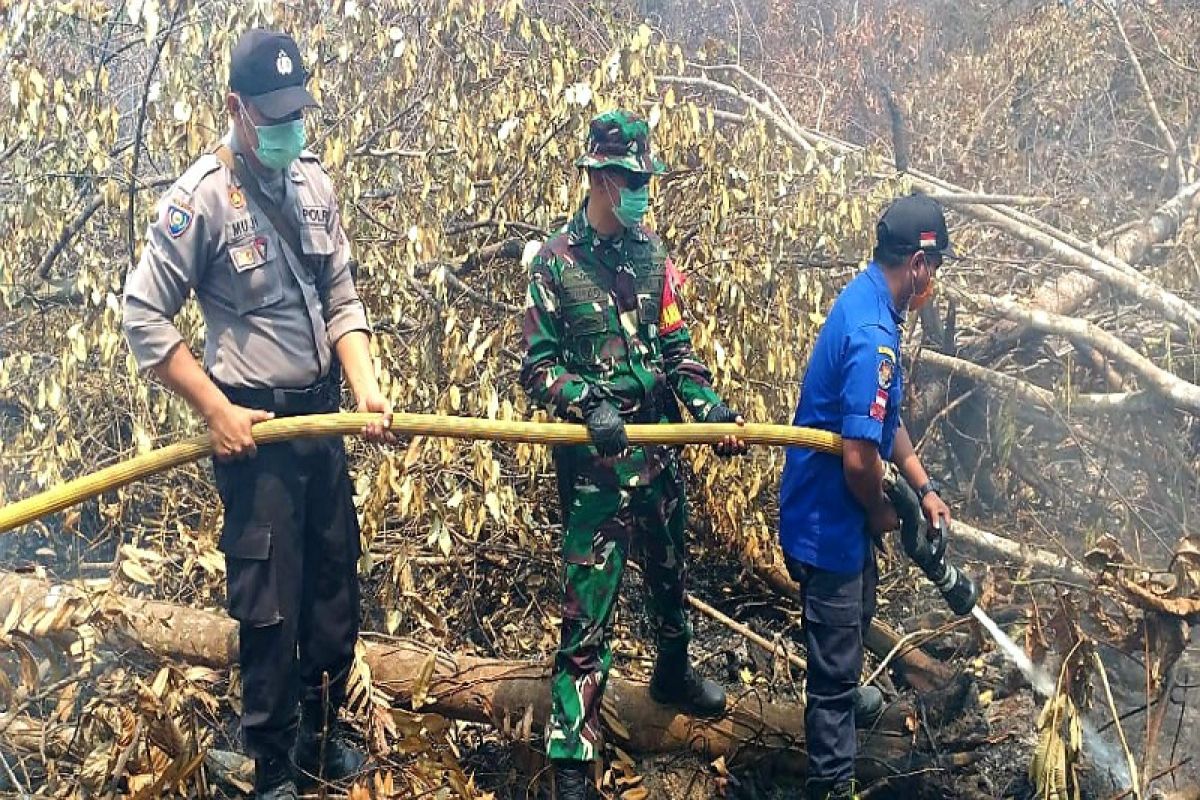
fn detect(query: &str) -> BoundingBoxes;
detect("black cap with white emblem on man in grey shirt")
[229,28,317,120]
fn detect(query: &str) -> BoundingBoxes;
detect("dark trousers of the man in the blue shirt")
[787,551,878,786]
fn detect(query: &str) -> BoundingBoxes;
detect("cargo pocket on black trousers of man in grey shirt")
[220,523,283,627]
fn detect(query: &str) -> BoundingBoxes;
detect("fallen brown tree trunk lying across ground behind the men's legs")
[0,572,936,780]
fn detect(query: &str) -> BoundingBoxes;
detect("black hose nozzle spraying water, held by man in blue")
[883,464,979,616]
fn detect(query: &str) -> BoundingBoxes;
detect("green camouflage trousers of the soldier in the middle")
[546,455,691,760]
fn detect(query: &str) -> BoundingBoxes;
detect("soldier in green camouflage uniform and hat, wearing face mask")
[521,110,745,800]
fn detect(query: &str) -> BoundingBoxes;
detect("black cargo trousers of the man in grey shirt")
[214,438,360,759]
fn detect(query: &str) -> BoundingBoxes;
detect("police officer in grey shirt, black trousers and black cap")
[124,29,395,800]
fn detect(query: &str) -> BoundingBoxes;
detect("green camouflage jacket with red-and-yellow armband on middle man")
[521,205,721,485]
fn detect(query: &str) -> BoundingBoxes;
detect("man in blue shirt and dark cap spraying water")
[779,194,953,800]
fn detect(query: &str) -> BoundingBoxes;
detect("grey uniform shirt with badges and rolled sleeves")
[122,135,370,389]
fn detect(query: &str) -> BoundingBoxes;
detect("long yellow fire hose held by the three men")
[0,414,841,533]
